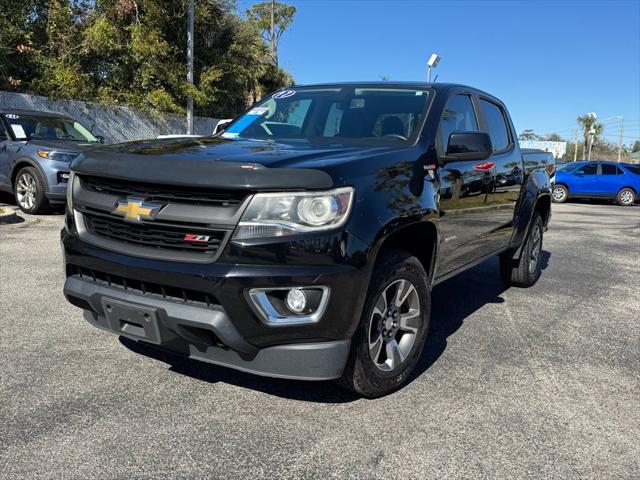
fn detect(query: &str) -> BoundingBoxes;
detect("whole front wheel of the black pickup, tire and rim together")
[339,250,431,398]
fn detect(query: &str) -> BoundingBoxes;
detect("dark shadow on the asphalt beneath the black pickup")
[120,250,551,403]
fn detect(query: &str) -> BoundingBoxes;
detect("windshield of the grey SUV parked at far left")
[5,114,98,142]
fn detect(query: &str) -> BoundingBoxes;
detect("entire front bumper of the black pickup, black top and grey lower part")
[61,230,369,380]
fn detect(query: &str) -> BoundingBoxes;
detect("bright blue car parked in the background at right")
[553,162,640,206]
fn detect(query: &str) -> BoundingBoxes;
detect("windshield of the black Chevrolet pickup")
[222,86,429,145]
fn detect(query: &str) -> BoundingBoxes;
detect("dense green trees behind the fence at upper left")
[0,0,293,117]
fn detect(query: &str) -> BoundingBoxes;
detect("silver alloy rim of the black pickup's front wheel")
[369,279,422,372]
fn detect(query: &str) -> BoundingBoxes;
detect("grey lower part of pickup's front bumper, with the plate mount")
[64,276,350,380]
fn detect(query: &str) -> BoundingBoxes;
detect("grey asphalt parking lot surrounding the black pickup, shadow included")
[0,197,640,479]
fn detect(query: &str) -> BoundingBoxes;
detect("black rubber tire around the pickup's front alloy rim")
[338,250,431,398]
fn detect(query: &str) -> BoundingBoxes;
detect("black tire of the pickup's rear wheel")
[500,212,544,288]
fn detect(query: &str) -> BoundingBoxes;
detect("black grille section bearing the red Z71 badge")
[83,211,228,255]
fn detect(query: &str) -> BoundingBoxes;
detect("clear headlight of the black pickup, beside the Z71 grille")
[234,187,354,240]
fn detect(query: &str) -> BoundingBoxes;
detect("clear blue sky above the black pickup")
[238,0,640,143]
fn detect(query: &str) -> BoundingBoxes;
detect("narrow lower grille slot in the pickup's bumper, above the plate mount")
[67,265,218,307]
